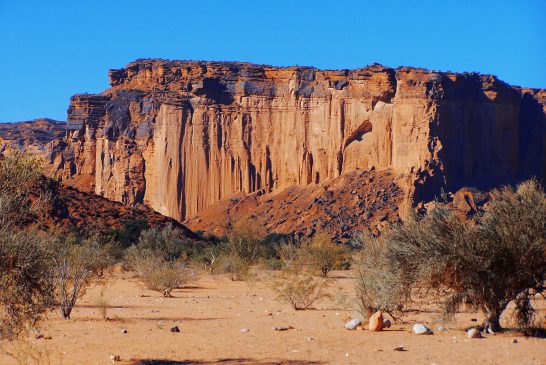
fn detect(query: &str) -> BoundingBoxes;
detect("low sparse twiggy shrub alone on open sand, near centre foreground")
[273,269,331,310]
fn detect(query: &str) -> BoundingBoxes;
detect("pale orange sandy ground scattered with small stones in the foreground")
[0,272,546,365]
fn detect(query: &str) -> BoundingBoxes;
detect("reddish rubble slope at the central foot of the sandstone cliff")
[186,170,404,241]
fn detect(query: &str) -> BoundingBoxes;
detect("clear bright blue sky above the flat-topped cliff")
[0,0,546,122]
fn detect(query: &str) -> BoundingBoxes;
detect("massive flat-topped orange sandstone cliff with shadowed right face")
[40,60,546,221]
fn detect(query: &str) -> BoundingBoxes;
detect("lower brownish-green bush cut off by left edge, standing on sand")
[0,228,54,338]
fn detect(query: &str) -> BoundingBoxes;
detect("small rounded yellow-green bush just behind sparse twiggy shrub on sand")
[301,234,347,276]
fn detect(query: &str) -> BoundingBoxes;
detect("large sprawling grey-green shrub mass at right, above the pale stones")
[356,181,546,330]
